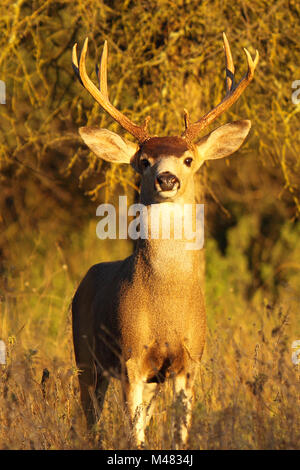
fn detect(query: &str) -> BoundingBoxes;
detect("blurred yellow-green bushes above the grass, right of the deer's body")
[205,214,300,326]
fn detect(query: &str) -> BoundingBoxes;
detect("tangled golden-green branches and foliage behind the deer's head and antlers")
[0,0,300,302]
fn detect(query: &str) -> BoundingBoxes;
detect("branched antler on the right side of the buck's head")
[182,33,259,142]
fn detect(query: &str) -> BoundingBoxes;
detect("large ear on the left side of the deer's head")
[79,127,138,163]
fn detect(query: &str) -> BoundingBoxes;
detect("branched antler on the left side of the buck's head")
[72,38,150,143]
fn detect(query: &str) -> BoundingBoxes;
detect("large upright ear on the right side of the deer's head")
[196,120,251,161]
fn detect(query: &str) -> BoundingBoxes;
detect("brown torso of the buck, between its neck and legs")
[73,235,205,370]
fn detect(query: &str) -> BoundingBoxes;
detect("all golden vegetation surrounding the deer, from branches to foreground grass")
[0,0,300,449]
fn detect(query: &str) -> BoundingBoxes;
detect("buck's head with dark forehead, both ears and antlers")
[72,33,259,204]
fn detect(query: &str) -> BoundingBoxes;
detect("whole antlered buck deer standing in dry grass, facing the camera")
[72,33,259,448]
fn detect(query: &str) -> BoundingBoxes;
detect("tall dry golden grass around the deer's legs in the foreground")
[0,300,300,449]
